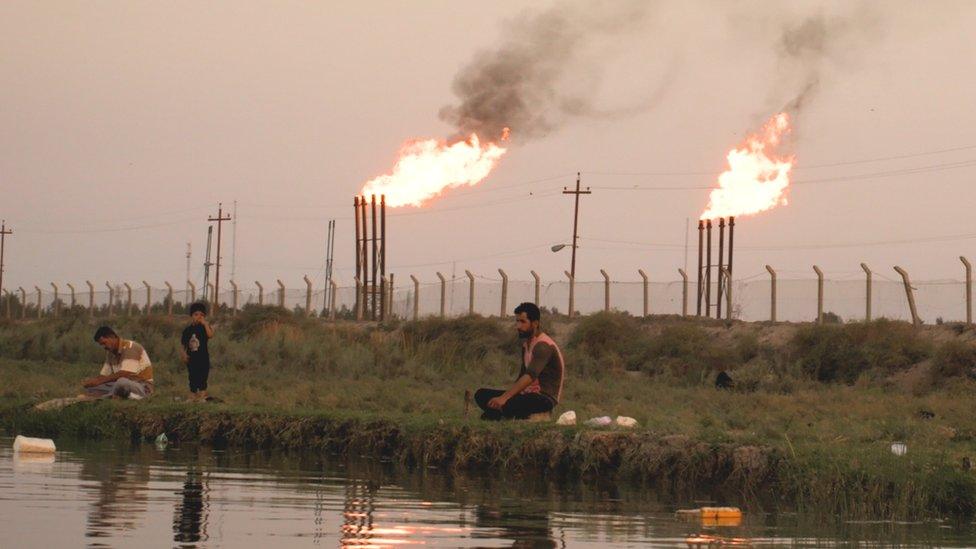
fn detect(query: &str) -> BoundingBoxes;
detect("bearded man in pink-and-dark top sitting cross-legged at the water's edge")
[474,303,565,420]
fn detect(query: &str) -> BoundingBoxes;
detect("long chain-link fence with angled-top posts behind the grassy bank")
[0,275,969,323]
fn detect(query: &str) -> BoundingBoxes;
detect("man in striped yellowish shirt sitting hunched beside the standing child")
[80,326,153,399]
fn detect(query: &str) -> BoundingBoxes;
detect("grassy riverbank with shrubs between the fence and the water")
[0,309,976,518]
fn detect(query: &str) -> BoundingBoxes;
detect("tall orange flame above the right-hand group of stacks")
[701,112,794,219]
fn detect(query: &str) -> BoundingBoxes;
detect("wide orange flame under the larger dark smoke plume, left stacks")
[360,133,508,208]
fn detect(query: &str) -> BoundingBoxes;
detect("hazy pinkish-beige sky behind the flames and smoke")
[0,0,976,296]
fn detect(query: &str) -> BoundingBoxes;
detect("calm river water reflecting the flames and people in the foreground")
[0,438,976,549]
